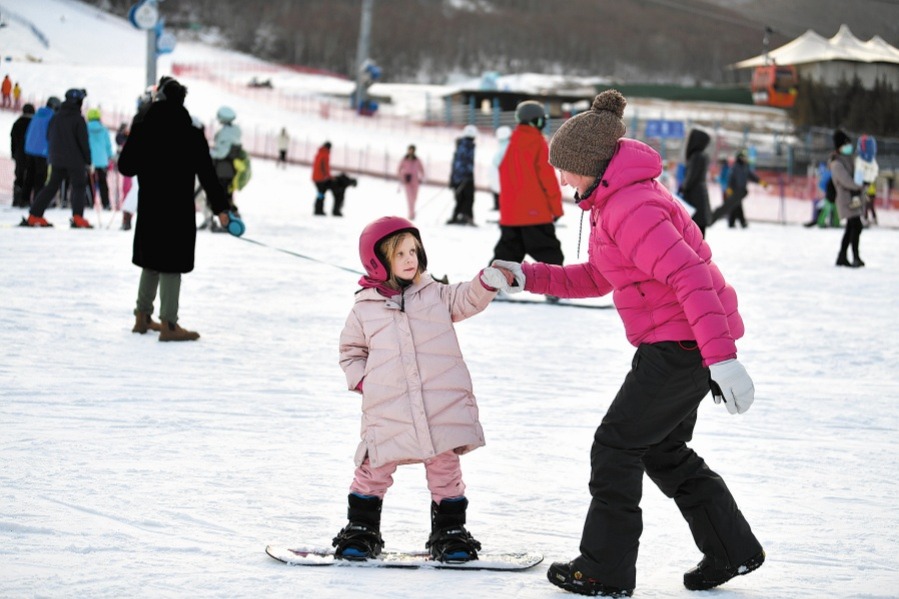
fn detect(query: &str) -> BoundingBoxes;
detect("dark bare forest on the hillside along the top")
[91,0,899,85]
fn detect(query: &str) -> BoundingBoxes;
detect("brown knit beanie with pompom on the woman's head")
[549,89,627,177]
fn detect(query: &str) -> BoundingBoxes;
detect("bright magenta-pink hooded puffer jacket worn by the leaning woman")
[522,138,743,365]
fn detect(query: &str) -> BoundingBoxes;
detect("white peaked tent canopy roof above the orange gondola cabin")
[733,25,899,69]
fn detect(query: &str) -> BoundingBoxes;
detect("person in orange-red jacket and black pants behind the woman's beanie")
[493,100,564,299]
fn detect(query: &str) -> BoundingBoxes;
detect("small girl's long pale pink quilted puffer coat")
[340,273,496,467]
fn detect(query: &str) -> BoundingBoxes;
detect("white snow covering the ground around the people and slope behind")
[0,0,899,599]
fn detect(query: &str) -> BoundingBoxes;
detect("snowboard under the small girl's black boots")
[265,545,543,572]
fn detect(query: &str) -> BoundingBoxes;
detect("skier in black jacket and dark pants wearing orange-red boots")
[22,89,93,229]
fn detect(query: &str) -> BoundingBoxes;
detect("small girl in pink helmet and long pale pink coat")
[334,216,512,562]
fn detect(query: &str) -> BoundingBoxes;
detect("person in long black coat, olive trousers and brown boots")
[118,79,229,341]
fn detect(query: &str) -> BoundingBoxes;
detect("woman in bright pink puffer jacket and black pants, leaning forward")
[494,90,765,597]
